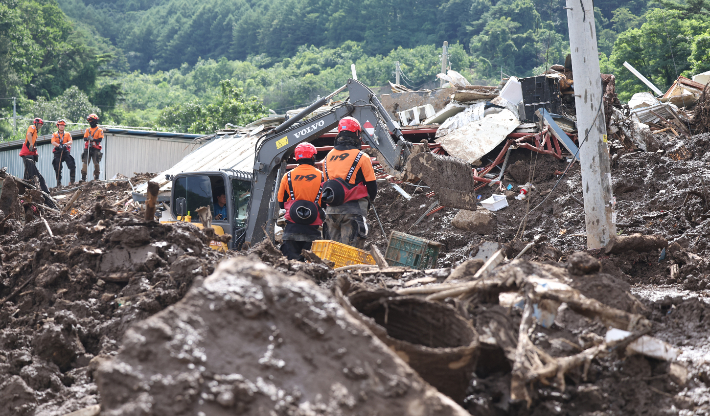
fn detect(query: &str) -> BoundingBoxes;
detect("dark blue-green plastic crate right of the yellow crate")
[385,231,442,270]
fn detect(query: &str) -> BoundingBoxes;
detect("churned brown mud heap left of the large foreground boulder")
[0,175,223,415]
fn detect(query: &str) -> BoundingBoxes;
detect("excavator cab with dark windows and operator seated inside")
[170,170,252,249]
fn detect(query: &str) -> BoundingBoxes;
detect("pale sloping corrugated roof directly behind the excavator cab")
[136,135,260,193]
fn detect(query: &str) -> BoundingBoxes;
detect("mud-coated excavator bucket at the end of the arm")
[406,152,476,211]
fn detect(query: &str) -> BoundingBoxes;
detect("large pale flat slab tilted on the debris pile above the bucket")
[436,109,520,163]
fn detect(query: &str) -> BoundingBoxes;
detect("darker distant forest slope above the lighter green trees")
[59,0,648,76]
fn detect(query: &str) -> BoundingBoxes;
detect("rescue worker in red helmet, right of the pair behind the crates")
[323,117,377,248]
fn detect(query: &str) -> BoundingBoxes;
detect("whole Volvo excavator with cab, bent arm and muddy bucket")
[171,79,476,250]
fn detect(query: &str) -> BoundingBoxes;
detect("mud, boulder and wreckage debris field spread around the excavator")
[9,65,710,415]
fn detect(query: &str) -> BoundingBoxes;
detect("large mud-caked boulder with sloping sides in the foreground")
[92,258,468,416]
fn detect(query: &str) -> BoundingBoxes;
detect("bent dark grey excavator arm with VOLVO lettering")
[245,79,475,244]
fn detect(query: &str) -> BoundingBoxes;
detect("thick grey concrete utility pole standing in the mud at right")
[565,0,616,249]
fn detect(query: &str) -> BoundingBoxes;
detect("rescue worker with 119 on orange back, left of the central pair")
[278,143,325,261]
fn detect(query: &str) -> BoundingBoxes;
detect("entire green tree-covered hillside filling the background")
[0,0,710,137]
